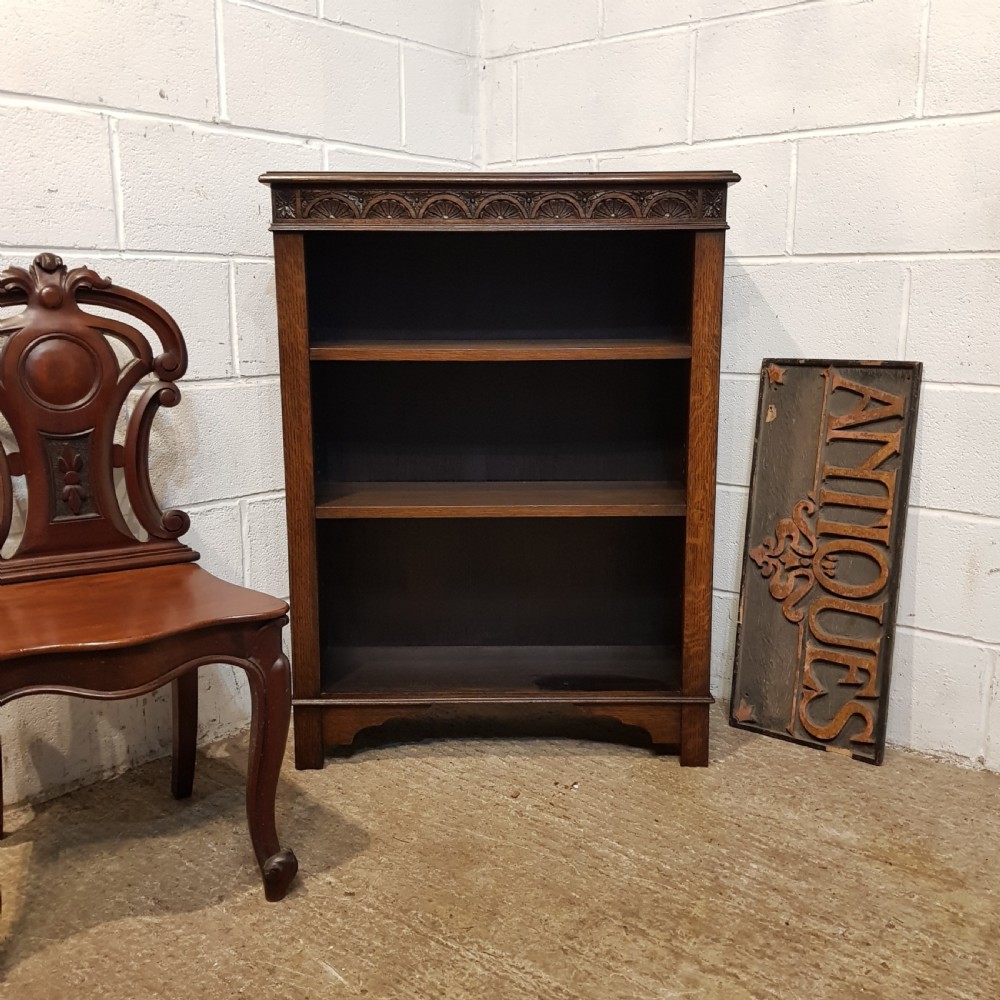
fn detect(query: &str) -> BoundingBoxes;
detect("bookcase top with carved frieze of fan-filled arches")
[260,171,740,231]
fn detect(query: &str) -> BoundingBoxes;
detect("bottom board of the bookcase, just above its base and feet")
[308,646,692,704]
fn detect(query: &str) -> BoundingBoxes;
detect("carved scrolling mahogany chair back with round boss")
[0,253,198,584]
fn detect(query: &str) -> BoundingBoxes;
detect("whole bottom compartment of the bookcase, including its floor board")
[317,517,684,691]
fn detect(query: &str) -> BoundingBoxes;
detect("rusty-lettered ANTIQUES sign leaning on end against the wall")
[730,359,921,764]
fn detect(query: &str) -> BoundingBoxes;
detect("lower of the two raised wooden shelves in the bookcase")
[316,482,686,518]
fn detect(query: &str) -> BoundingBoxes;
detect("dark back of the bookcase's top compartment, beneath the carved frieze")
[306,230,693,343]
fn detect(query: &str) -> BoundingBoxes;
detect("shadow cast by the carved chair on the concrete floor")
[0,738,369,981]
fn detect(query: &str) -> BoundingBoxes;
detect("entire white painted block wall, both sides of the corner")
[0,0,1000,800]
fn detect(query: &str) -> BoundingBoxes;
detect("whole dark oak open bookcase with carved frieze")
[262,173,738,767]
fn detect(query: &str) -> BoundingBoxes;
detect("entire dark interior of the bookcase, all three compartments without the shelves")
[306,229,692,697]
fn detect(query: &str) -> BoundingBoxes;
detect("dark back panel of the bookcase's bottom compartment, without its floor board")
[317,518,684,647]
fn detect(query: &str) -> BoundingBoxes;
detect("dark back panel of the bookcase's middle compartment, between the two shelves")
[312,361,688,483]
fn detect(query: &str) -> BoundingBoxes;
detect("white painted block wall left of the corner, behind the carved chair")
[0,0,479,802]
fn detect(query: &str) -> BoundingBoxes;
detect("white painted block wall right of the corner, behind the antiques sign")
[481,0,1000,770]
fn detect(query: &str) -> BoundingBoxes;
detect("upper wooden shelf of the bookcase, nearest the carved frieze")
[309,338,691,361]
